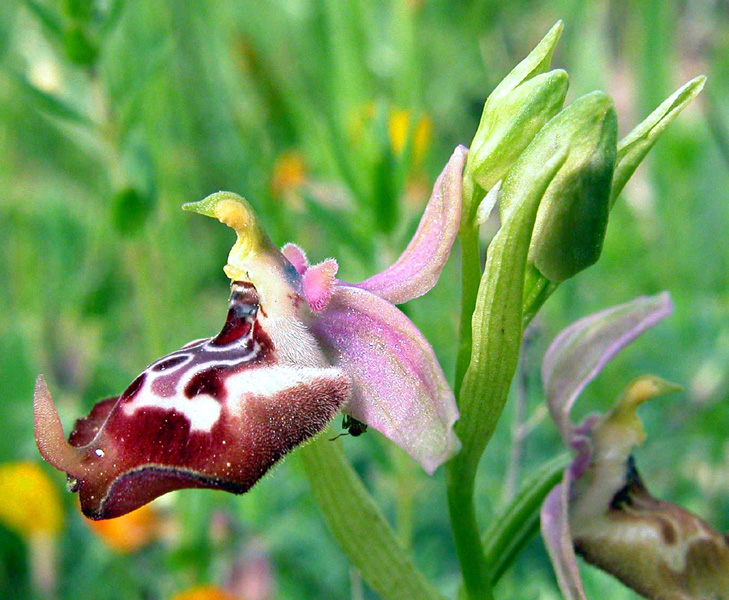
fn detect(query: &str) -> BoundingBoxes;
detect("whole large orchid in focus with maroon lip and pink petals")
[34,147,466,519]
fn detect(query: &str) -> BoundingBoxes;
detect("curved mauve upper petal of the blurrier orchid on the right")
[542,292,673,444]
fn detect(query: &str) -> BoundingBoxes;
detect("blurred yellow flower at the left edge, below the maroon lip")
[0,462,63,538]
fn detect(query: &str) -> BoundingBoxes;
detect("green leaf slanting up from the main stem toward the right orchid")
[483,454,570,585]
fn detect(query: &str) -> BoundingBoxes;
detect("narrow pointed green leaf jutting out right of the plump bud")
[610,75,706,207]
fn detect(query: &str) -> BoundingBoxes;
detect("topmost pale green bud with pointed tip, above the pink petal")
[464,22,569,222]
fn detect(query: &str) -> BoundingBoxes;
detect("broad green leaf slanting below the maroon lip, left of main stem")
[296,432,441,600]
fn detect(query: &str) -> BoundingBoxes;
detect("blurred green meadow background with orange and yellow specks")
[0,0,729,600]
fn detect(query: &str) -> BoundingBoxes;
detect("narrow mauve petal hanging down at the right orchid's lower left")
[541,482,587,600]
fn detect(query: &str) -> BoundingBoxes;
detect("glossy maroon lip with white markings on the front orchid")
[35,282,349,519]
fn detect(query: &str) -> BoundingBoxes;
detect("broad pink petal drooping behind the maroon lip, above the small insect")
[314,285,460,474]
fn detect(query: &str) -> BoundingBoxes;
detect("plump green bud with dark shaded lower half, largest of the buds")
[501,92,618,282]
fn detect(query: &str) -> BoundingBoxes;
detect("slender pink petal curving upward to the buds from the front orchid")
[354,146,467,304]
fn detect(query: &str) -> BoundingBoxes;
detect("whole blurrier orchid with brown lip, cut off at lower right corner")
[541,293,729,600]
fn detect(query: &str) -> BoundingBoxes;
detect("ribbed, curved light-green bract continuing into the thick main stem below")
[446,150,567,600]
